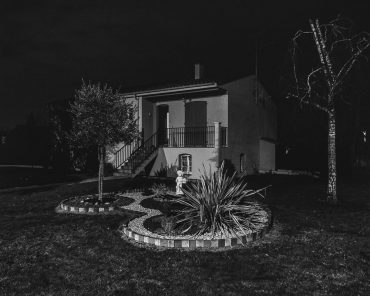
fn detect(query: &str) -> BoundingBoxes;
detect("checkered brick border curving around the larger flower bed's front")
[119,209,273,249]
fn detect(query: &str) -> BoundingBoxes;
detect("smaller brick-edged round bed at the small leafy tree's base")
[59,193,134,214]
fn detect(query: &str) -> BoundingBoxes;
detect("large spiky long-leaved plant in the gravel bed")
[174,164,267,236]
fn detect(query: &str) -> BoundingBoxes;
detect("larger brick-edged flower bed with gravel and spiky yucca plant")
[121,164,272,248]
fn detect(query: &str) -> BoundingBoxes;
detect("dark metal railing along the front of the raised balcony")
[160,126,227,148]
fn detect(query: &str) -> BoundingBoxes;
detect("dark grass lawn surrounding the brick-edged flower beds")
[0,178,370,295]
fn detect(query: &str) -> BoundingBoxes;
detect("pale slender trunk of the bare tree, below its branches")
[327,110,337,204]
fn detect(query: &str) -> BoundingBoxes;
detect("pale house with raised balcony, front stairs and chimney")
[110,64,277,178]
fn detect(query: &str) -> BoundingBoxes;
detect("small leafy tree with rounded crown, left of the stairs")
[70,82,138,201]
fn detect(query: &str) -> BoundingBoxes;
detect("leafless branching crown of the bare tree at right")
[288,17,370,113]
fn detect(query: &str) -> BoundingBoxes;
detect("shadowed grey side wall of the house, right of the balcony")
[221,76,277,173]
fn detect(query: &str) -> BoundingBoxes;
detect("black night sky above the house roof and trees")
[0,0,370,130]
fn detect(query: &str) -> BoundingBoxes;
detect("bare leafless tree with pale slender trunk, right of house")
[287,18,370,203]
